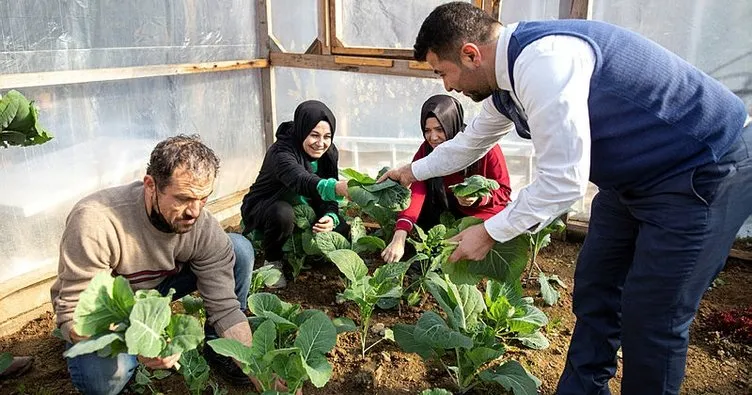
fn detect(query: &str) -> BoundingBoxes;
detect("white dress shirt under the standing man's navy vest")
[412,24,595,242]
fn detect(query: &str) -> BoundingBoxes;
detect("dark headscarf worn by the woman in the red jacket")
[420,95,465,211]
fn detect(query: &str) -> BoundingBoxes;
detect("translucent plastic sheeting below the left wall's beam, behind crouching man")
[0,70,266,282]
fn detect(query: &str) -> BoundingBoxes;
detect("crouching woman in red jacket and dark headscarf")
[381,95,512,262]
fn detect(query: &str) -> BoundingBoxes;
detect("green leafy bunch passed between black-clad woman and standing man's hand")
[340,168,410,211]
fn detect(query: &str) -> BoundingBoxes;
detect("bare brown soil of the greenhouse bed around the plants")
[0,241,752,395]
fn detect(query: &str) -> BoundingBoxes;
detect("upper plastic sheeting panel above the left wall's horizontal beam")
[0,0,257,73]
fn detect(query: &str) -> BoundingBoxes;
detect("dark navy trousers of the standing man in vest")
[557,126,752,395]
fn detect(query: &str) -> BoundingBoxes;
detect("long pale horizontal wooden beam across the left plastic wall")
[0,59,269,90]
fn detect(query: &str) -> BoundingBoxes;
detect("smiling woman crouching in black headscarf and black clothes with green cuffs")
[240,100,347,288]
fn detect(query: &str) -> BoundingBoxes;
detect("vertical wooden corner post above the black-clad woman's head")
[256,0,277,147]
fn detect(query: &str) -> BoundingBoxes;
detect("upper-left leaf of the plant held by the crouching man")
[73,272,129,336]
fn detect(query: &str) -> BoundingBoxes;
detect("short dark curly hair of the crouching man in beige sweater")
[146,134,219,191]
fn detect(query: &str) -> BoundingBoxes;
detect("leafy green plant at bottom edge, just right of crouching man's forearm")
[208,292,337,393]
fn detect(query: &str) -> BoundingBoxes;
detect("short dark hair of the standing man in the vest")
[414,1,499,61]
